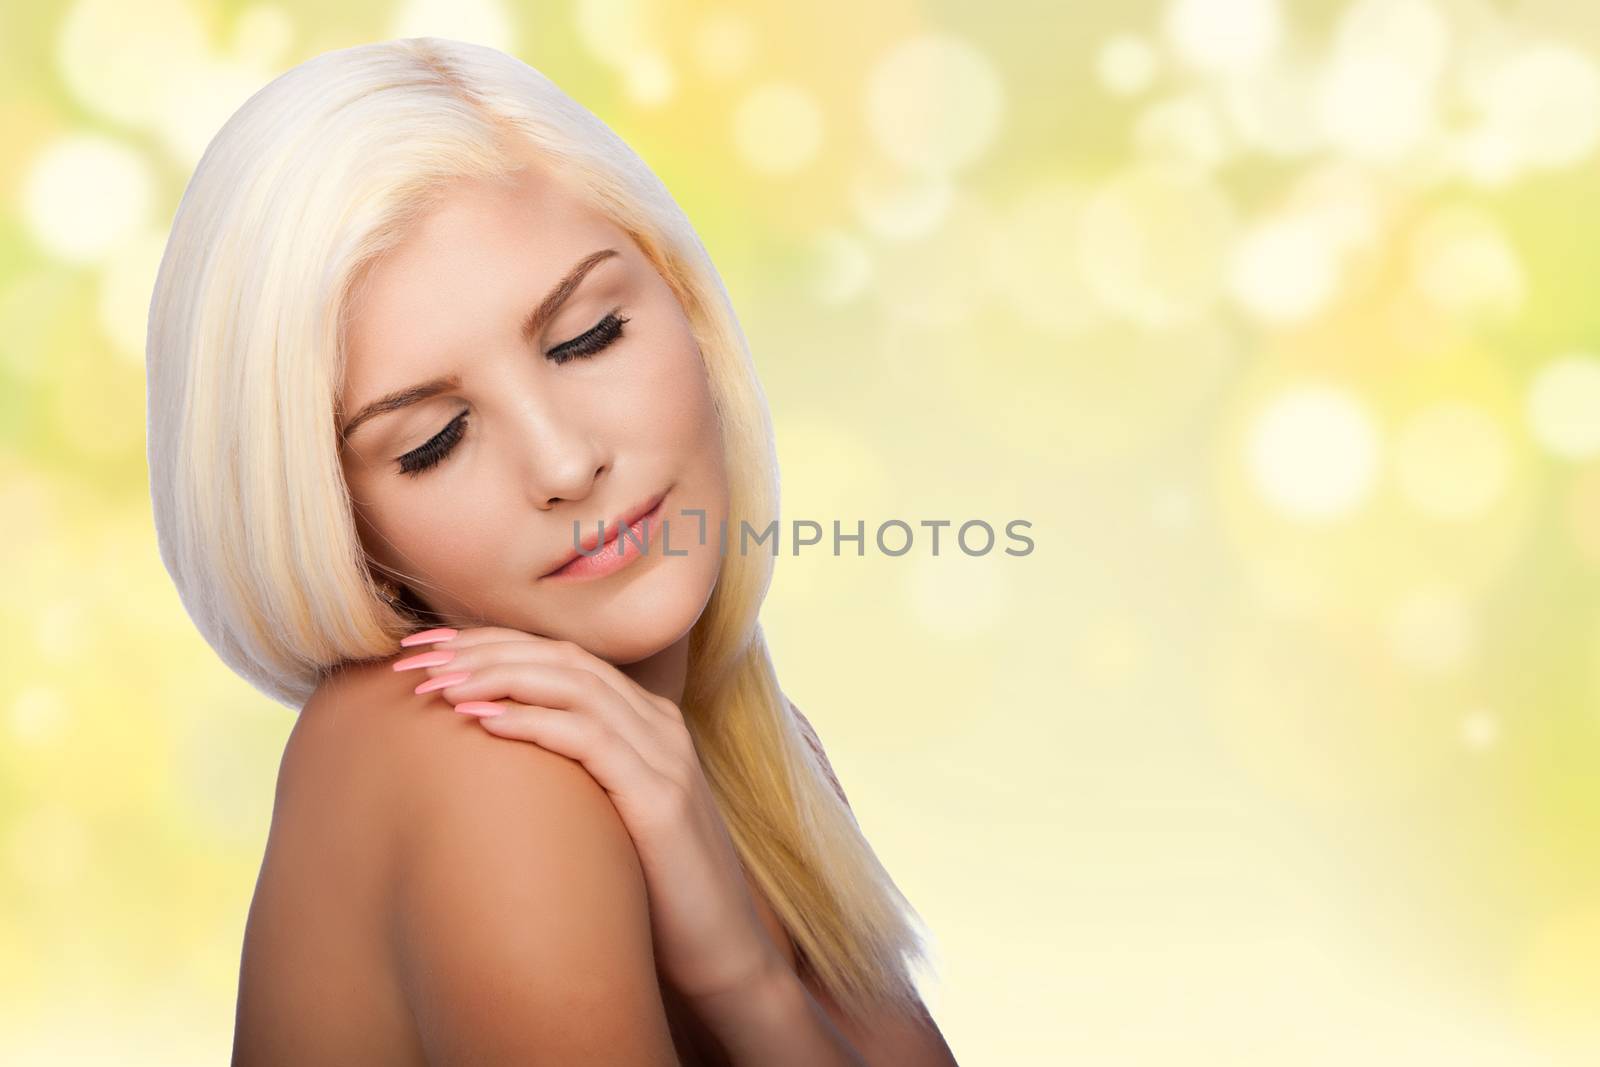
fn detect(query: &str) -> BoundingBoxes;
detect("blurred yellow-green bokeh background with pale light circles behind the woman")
[0,0,1600,1067]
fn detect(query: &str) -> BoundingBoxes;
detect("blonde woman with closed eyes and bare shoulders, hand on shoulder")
[149,38,954,1067]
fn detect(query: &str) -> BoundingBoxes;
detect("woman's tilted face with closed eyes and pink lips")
[341,159,728,664]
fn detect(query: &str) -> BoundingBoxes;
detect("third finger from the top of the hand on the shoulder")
[442,661,685,777]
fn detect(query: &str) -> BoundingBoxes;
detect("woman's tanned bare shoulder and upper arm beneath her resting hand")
[291,661,677,1065]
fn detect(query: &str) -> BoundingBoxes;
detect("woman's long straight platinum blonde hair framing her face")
[147,37,926,1019]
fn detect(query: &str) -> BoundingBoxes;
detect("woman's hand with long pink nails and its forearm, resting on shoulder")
[387,627,787,1005]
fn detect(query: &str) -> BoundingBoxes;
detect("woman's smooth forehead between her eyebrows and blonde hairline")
[342,166,620,400]
